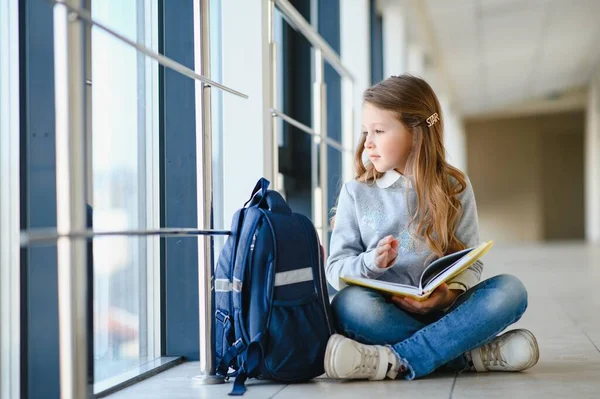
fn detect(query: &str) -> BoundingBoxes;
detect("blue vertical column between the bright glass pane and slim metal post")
[158,0,200,360]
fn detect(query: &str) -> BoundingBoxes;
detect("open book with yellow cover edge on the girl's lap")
[341,241,494,301]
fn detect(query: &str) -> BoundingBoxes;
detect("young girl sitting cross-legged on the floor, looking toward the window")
[325,75,539,380]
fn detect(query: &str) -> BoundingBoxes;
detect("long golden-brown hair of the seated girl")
[355,75,467,257]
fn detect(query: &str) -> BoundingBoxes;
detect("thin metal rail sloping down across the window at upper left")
[50,0,248,99]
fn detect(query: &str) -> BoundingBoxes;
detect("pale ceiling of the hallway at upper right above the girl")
[426,0,600,115]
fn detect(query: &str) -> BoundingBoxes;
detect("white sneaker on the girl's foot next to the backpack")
[325,334,401,380]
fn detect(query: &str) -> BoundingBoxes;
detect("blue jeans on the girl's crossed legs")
[332,274,527,380]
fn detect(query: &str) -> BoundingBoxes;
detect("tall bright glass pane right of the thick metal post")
[91,0,160,388]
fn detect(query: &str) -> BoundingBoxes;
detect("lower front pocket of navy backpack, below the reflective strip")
[264,294,330,382]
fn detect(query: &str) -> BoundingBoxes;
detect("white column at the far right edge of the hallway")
[584,70,600,243]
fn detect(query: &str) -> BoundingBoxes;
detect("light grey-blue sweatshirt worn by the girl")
[326,170,483,291]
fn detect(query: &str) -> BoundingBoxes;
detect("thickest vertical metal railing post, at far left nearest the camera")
[54,0,88,399]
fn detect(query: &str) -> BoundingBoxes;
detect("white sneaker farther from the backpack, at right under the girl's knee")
[470,330,540,371]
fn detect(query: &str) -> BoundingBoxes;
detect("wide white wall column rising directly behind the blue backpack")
[221,0,274,228]
